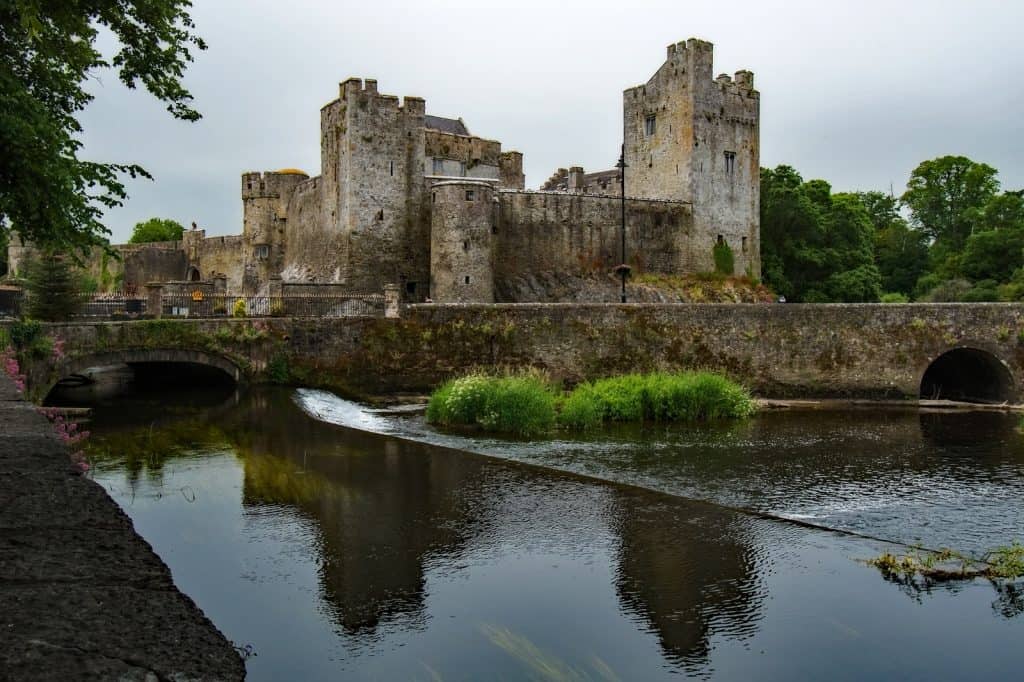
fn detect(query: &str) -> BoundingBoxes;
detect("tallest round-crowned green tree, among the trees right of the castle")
[901,157,999,249]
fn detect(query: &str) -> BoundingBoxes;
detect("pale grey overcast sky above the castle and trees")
[81,0,1024,242]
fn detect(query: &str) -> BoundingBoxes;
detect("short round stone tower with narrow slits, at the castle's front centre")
[430,180,495,303]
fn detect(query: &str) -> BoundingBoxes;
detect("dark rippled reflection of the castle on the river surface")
[92,392,761,672]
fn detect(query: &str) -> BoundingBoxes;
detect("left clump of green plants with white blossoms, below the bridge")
[427,373,555,435]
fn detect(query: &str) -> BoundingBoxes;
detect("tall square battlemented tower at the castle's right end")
[623,39,761,275]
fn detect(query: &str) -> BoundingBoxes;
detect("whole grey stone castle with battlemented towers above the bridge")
[9,39,760,302]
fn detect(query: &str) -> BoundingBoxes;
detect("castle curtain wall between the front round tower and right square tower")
[494,190,692,299]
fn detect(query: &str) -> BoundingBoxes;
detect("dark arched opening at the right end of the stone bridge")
[920,346,1020,402]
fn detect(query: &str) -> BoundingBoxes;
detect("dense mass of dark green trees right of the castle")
[761,157,1024,302]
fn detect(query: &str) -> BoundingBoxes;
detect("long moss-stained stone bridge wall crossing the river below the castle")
[4,303,1024,401]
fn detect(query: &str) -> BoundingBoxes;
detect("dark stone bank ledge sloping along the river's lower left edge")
[0,375,245,680]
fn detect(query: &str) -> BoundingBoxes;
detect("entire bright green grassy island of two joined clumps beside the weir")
[427,372,754,435]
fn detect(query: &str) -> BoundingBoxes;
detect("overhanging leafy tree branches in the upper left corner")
[0,0,206,253]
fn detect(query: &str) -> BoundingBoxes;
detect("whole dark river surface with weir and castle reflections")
[81,388,1024,680]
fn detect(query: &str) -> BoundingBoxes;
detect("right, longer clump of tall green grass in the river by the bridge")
[558,372,755,429]
